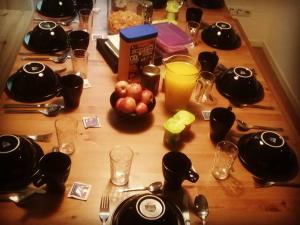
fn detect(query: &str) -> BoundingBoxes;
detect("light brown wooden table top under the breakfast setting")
[0,1,300,225]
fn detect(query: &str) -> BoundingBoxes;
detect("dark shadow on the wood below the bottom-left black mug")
[19,193,64,223]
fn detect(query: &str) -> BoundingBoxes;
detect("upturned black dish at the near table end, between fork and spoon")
[111,195,185,225]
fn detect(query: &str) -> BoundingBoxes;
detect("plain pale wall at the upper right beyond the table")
[225,0,300,114]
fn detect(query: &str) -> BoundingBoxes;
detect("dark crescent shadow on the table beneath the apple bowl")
[107,109,154,133]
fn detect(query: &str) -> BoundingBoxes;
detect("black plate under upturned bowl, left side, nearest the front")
[0,136,44,191]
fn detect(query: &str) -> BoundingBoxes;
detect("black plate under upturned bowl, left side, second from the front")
[5,74,60,103]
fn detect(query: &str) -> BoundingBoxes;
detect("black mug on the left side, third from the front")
[68,30,90,50]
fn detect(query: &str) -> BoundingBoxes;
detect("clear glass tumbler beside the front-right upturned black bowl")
[212,141,238,180]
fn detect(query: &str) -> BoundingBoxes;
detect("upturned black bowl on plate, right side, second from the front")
[216,66,264,104]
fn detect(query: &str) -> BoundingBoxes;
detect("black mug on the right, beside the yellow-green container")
[209,107,235,143]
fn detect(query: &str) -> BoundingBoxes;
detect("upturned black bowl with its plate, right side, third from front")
[201,21,241,50]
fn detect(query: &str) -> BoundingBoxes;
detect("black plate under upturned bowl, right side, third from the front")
[201,27,241,50]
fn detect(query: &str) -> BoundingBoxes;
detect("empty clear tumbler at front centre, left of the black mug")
[109,145,133,186]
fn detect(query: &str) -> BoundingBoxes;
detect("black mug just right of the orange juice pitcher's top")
[198,51,219,73]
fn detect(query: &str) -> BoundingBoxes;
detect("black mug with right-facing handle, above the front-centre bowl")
[162,152,199,189]
